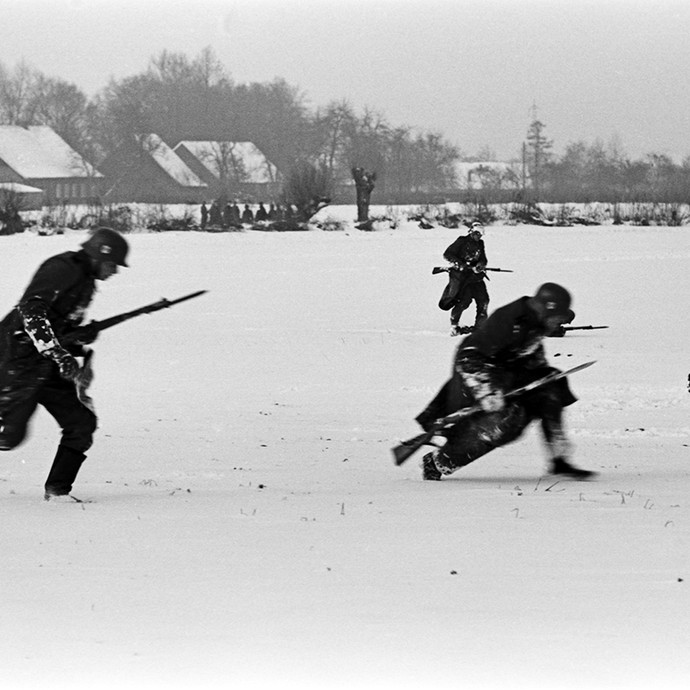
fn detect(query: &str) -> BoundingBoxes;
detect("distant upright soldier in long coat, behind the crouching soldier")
[438,222,489,335]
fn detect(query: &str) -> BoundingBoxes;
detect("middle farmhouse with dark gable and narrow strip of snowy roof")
[99,134,209,204]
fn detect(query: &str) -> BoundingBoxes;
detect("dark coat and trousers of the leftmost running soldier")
[0,250,96,456]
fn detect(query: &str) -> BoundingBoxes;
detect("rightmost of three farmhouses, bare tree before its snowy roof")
[174,141,280,201]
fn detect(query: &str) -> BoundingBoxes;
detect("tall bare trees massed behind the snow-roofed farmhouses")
[0,49,460,203]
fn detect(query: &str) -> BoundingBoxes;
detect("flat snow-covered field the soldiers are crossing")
[0,208,690,690]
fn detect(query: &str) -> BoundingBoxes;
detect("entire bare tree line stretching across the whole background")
[0,48,690,203]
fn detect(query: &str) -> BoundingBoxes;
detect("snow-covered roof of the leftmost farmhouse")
[0,125,103,179]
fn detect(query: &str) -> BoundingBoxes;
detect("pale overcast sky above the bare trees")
[0,0,690,162]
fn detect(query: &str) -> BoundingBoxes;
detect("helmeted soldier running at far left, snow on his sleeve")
[0,228,128,500]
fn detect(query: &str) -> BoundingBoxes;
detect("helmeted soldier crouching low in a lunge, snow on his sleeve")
[417,283,594,480]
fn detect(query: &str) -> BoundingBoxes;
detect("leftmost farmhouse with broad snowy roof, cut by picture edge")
[0,125,103,208]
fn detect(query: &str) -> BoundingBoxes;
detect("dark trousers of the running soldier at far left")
[0,368,97,453]
